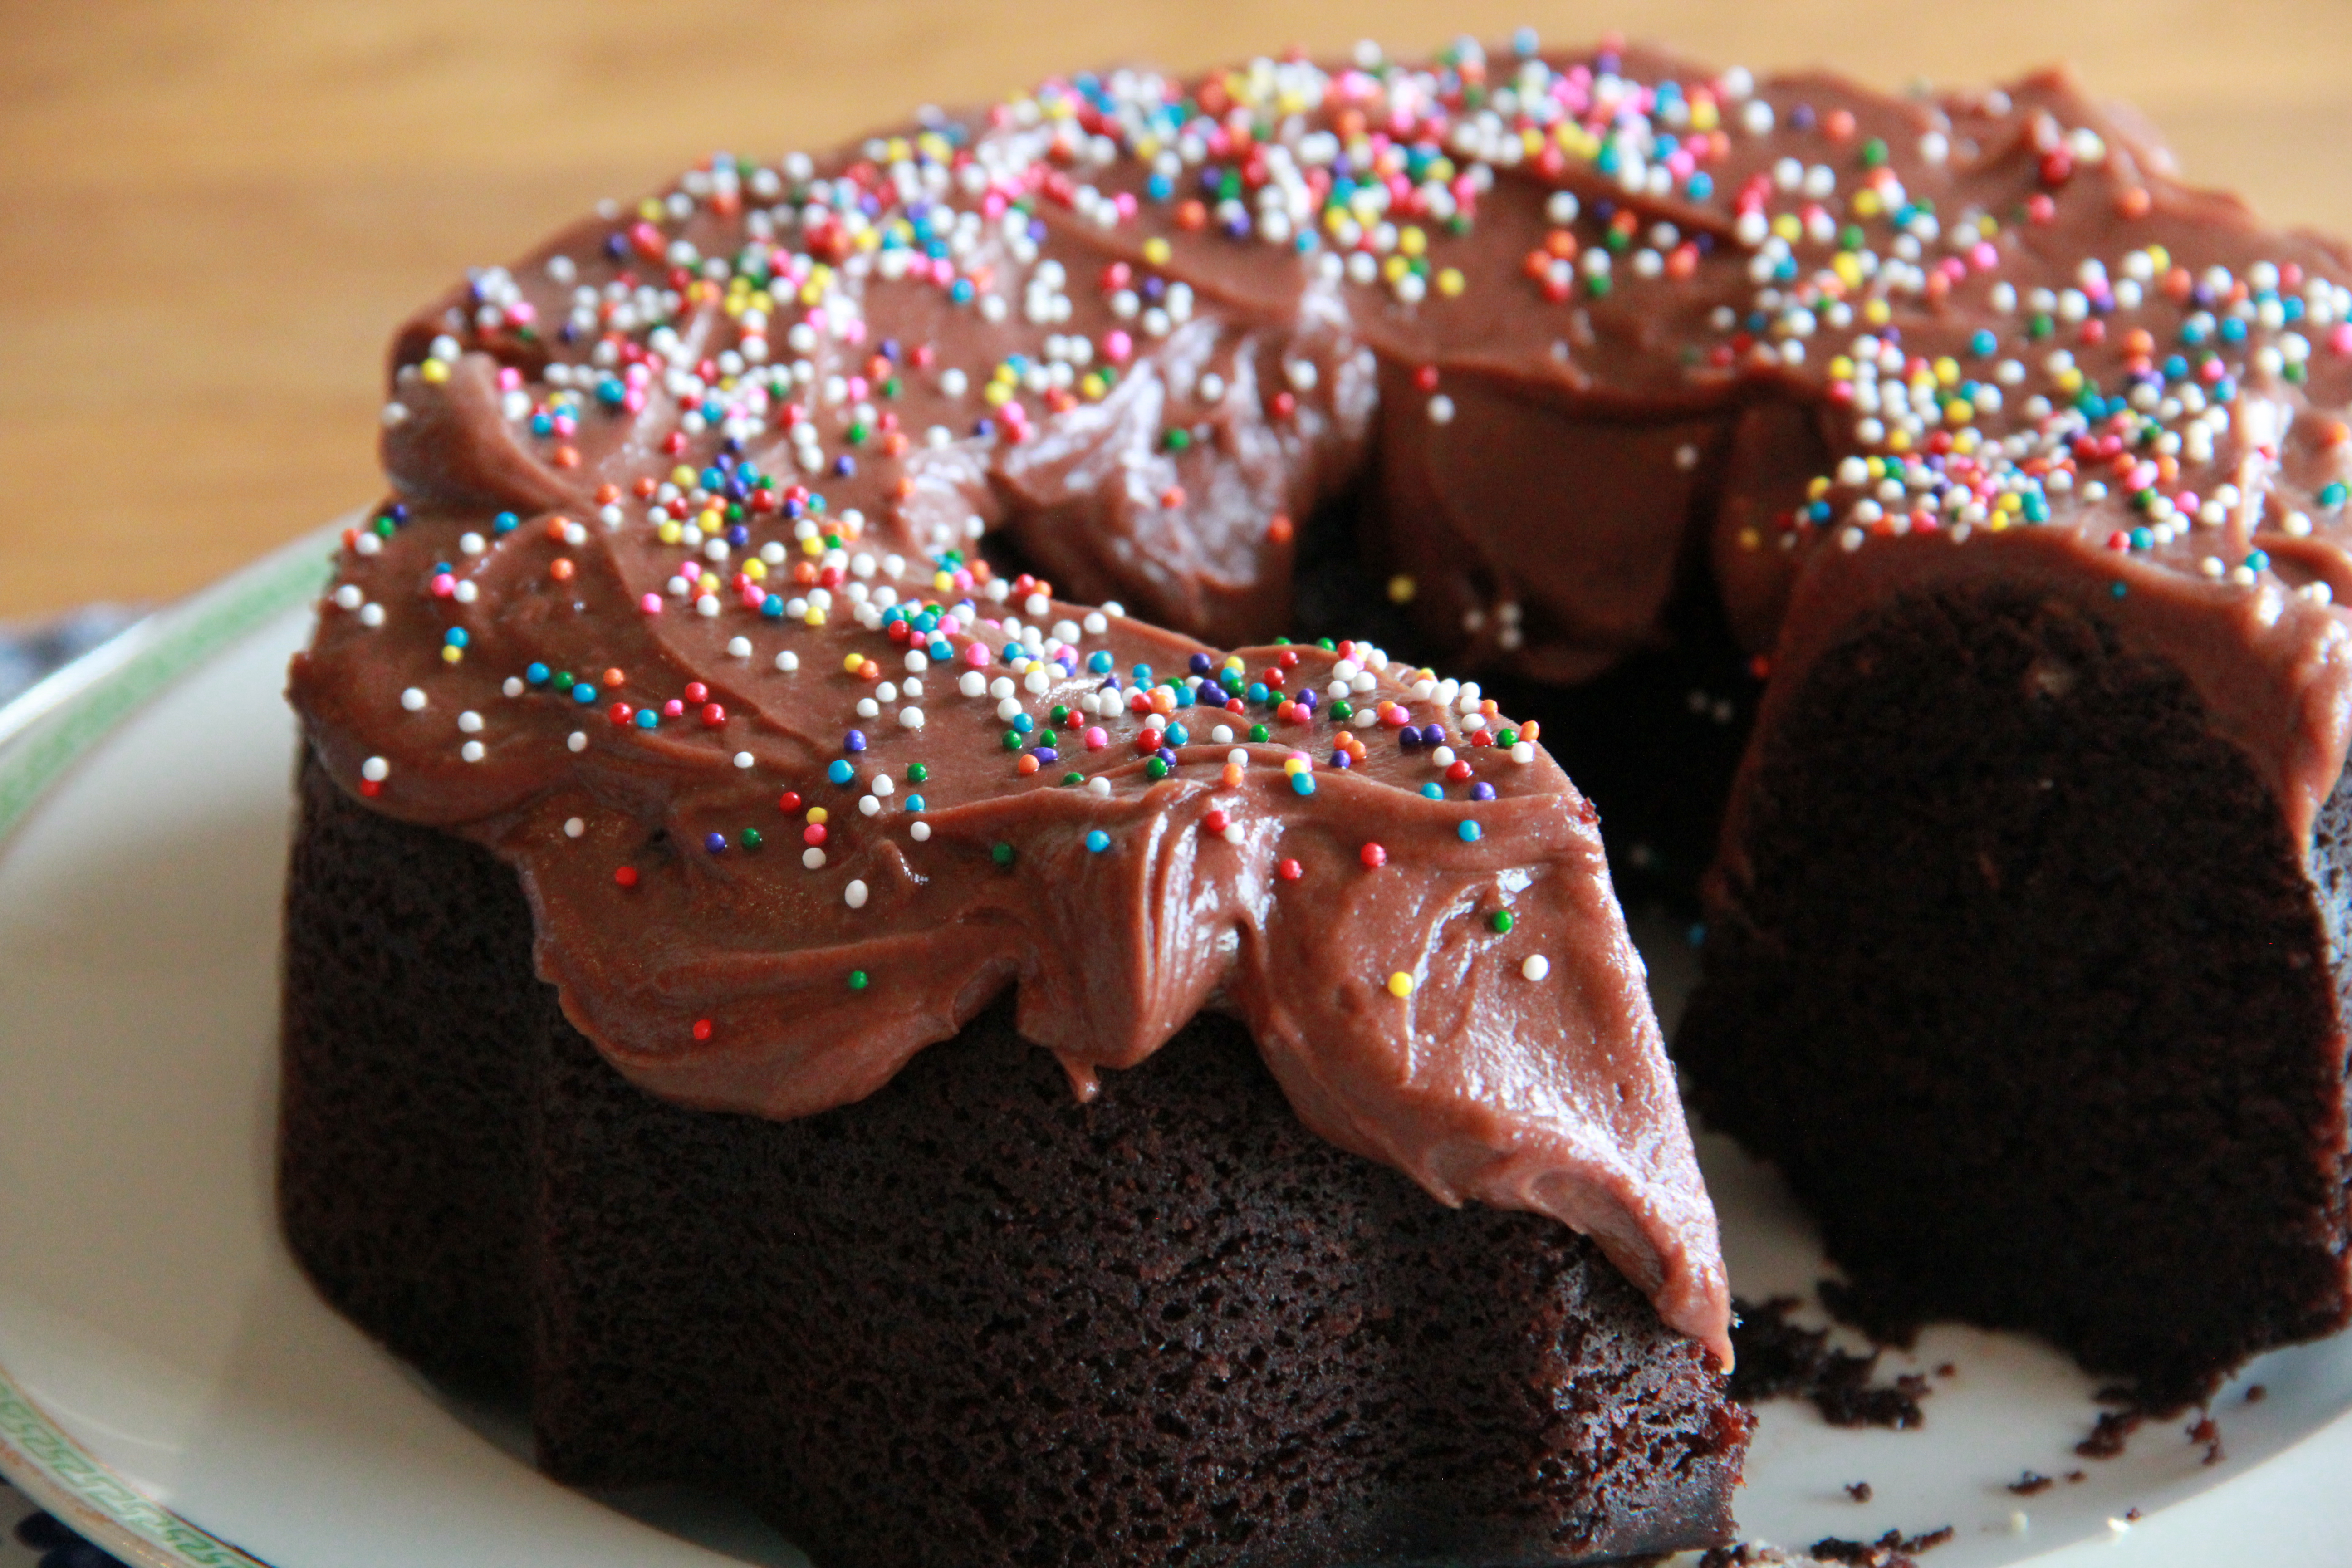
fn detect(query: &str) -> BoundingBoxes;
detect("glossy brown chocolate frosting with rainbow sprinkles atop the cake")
[292,30,2352,1361]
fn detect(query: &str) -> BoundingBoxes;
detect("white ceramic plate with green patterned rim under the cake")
[0,534,2352,1568]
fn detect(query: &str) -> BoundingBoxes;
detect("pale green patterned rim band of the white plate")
[0,522,343,1568]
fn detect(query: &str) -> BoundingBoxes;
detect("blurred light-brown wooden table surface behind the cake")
[0,0,2352,616]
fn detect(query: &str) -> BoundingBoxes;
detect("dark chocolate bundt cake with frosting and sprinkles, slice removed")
[282,40,2352,1563]
